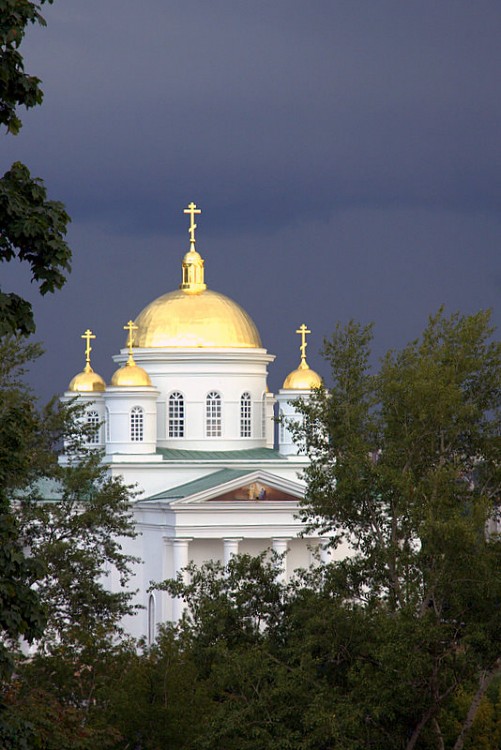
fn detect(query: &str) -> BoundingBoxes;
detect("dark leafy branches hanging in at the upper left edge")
[0,0,71,336]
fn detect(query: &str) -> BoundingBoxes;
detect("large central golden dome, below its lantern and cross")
[134,290,261,349]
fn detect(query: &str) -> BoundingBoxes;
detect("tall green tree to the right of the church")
[290,311,501,750]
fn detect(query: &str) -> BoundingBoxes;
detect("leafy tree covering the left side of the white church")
[0,338,136,660]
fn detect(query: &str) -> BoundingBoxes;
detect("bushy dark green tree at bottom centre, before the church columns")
[152,555,367,750]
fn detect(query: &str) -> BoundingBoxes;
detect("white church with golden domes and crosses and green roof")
[64,203,326,641]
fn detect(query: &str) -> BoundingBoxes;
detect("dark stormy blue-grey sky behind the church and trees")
[0,0,501,406]
